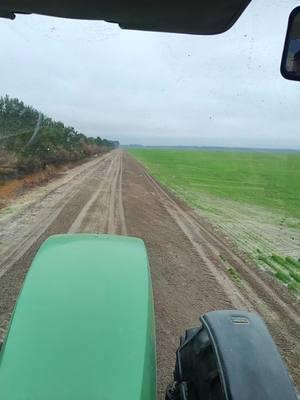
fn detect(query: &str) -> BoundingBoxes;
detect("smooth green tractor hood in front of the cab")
[0,234,156,400]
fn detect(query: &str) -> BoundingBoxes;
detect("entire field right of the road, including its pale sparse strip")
[128,149,300,296]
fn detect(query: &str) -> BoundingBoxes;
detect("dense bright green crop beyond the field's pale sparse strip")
[128,148,300,218]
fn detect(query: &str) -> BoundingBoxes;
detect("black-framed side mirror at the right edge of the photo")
[280,7,300,81]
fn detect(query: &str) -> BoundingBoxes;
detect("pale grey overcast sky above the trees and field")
[0,0,300,149]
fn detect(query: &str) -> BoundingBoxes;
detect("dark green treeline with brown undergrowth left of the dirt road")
[0,96,119,177]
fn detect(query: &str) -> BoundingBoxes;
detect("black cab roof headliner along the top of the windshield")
[0,0,251,35]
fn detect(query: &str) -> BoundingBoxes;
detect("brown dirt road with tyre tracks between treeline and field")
[0,150,300,399]
